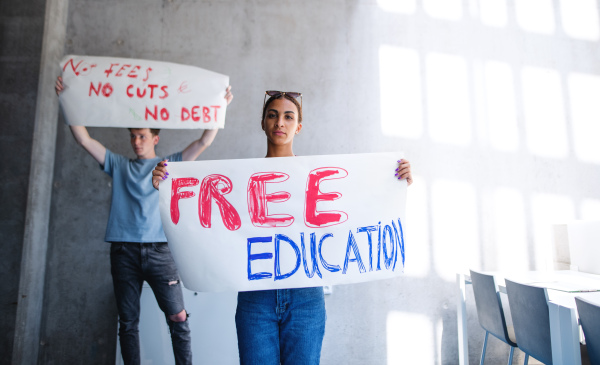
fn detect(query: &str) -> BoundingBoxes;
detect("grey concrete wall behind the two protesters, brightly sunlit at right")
[2,0,600,364]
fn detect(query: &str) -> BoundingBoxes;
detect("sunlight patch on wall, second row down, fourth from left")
[522,66,568,158]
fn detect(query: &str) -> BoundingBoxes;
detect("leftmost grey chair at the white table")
[471,270,517,365]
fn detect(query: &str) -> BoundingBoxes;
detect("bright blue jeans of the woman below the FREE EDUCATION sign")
[235,287,326,365]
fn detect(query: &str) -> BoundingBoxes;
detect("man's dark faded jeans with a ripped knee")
[110,242,192,365]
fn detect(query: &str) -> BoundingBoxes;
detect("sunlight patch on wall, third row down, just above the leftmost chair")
[492,187,529,271]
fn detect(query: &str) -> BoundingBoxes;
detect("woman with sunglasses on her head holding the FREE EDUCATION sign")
[152,91,412,365]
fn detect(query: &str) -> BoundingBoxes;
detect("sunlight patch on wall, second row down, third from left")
[484,61,519,152]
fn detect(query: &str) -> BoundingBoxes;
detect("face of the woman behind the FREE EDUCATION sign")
[262,98,302,145]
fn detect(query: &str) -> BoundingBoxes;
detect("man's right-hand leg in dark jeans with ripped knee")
[143,243,192,365]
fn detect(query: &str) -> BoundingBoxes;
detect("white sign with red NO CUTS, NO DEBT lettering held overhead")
[59,55,229,129]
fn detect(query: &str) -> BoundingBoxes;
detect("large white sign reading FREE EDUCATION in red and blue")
[159,153,406,291]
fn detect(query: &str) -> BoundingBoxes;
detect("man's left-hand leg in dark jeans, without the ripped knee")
[110,243,143,365]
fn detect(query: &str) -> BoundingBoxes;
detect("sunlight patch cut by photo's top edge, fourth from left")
[515,0,556,34]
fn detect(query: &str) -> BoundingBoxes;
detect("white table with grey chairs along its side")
[456,270,600,365]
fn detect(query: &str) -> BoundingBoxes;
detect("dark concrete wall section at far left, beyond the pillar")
[0,0,46,364]
